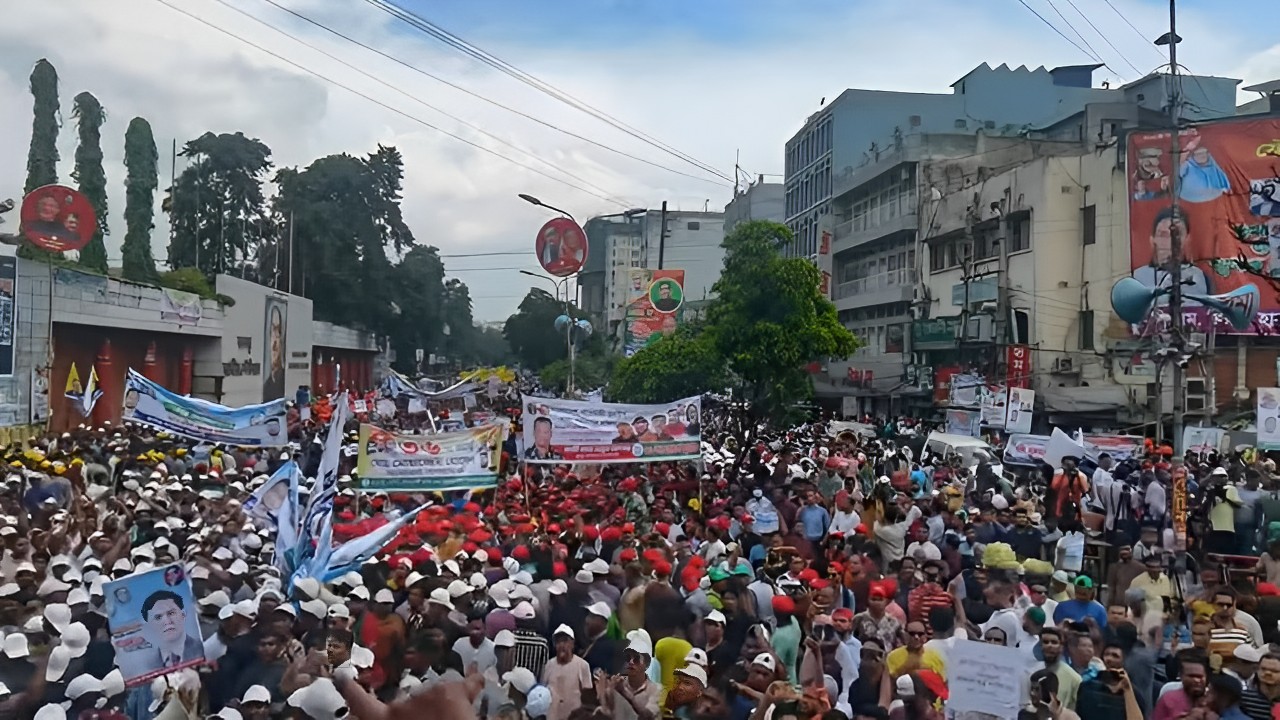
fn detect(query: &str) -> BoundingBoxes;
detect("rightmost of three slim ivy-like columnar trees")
[122,118,160,283]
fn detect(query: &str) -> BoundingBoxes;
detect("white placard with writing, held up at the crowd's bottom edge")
[946,641,1029,720]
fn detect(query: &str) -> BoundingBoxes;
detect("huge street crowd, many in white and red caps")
[0,410,1280,720]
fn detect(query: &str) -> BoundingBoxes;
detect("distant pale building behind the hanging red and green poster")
[579,208,724,334]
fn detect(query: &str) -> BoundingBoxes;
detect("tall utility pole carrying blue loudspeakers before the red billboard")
[1157,0,1182,457]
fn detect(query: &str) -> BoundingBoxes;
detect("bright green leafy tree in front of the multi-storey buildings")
[707,220,859,425]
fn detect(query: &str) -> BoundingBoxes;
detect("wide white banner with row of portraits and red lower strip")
[521,396,701,464]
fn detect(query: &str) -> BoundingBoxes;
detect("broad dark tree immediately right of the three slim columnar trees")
[164,132,271,279]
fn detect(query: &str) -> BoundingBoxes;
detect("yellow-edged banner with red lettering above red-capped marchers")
[356,421,509,492]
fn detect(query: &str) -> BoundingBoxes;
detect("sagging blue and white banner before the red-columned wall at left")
[122,369,289,447]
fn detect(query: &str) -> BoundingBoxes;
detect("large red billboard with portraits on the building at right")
[1126,118,1280,334]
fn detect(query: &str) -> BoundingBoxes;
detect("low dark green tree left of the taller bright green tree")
[605,327,730,402]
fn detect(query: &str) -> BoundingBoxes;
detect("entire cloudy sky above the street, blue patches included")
[0,0,1280,320]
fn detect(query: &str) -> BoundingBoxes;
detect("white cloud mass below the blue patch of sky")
[0,0,1280,320]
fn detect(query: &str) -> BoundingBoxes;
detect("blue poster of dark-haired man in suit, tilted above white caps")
[102,564,205,687]
